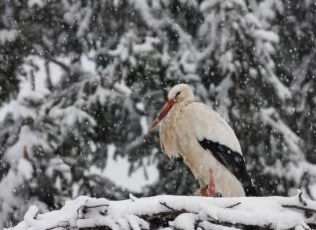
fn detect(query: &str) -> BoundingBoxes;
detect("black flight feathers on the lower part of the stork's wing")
[199,139,259,196]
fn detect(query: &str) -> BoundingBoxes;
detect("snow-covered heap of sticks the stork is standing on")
[6,192,316,230]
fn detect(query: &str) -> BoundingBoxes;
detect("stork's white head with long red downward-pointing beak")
[150,84,194,130]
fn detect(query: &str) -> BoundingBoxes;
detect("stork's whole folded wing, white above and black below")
[186,103,258,196]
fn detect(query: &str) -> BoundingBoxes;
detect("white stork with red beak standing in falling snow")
[150,84,258,197]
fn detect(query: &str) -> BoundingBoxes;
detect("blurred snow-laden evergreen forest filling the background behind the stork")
[0,0,316,229]
